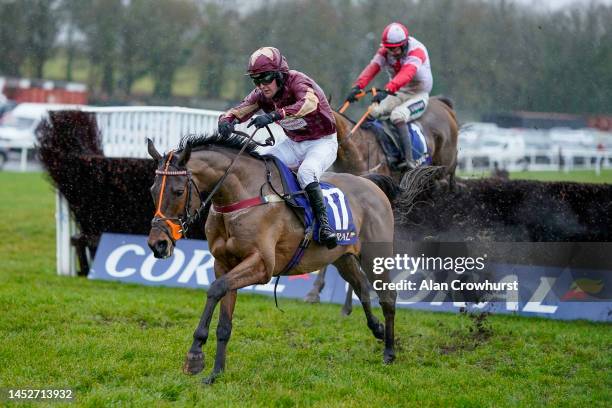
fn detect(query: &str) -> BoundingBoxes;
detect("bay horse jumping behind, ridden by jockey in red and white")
[304,96,459,315]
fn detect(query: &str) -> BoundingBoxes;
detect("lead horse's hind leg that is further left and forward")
[334,254,385,340]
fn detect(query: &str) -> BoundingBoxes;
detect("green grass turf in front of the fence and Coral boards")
[0,172,612,407]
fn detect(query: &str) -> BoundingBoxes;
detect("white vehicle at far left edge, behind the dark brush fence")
[0,103,84,149]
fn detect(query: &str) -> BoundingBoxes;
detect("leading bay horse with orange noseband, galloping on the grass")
[148,133,397,384]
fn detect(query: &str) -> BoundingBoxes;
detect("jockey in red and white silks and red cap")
[346,23,433,168]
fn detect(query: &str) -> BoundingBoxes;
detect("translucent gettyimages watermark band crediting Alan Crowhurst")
[362,241,612,303]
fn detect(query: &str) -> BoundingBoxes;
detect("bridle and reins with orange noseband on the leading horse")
[151,126,275,244]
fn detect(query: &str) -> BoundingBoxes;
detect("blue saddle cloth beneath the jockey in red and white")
[361,118,431,169]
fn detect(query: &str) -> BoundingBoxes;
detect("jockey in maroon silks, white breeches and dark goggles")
[219,47,338,249]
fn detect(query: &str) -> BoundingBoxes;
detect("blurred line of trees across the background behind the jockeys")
[0,0,612,113]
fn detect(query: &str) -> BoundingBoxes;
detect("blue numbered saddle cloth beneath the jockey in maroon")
[266,156,359,245]
